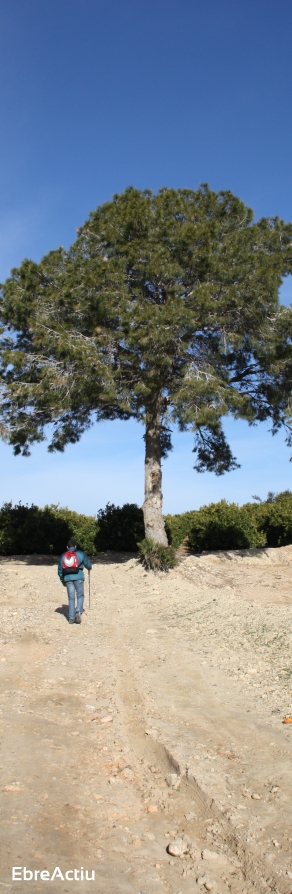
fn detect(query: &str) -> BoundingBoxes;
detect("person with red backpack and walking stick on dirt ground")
[58,540,92,624]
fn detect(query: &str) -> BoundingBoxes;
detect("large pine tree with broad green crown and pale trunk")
[0,185,292,544]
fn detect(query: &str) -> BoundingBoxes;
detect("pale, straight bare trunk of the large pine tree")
[142,400,168,546]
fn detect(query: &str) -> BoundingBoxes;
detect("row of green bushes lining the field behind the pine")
[0,491,292,555]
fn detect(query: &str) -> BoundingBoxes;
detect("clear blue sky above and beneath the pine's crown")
[0,0,292,513]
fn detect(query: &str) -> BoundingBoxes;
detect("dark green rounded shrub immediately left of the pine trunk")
[95,503,145,553]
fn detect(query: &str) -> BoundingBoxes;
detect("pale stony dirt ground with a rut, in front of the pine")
[0,547,292,894]
